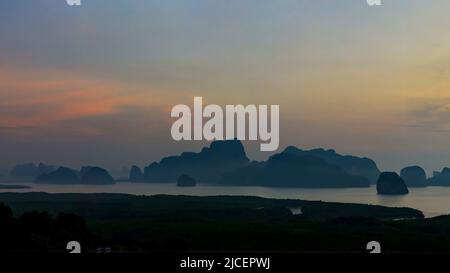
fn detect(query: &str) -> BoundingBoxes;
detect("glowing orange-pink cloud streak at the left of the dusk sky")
[0,69,175,128]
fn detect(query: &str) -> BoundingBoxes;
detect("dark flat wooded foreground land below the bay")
[0,193,450,252]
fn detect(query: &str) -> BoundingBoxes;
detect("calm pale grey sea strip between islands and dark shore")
[0,182,450,217]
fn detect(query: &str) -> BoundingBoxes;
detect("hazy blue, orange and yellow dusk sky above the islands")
[0,0,450,174]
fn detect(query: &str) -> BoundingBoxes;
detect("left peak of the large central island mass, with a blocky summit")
[144,140,249,183]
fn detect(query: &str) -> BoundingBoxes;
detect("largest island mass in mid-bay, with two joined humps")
[130,140,379,188]
